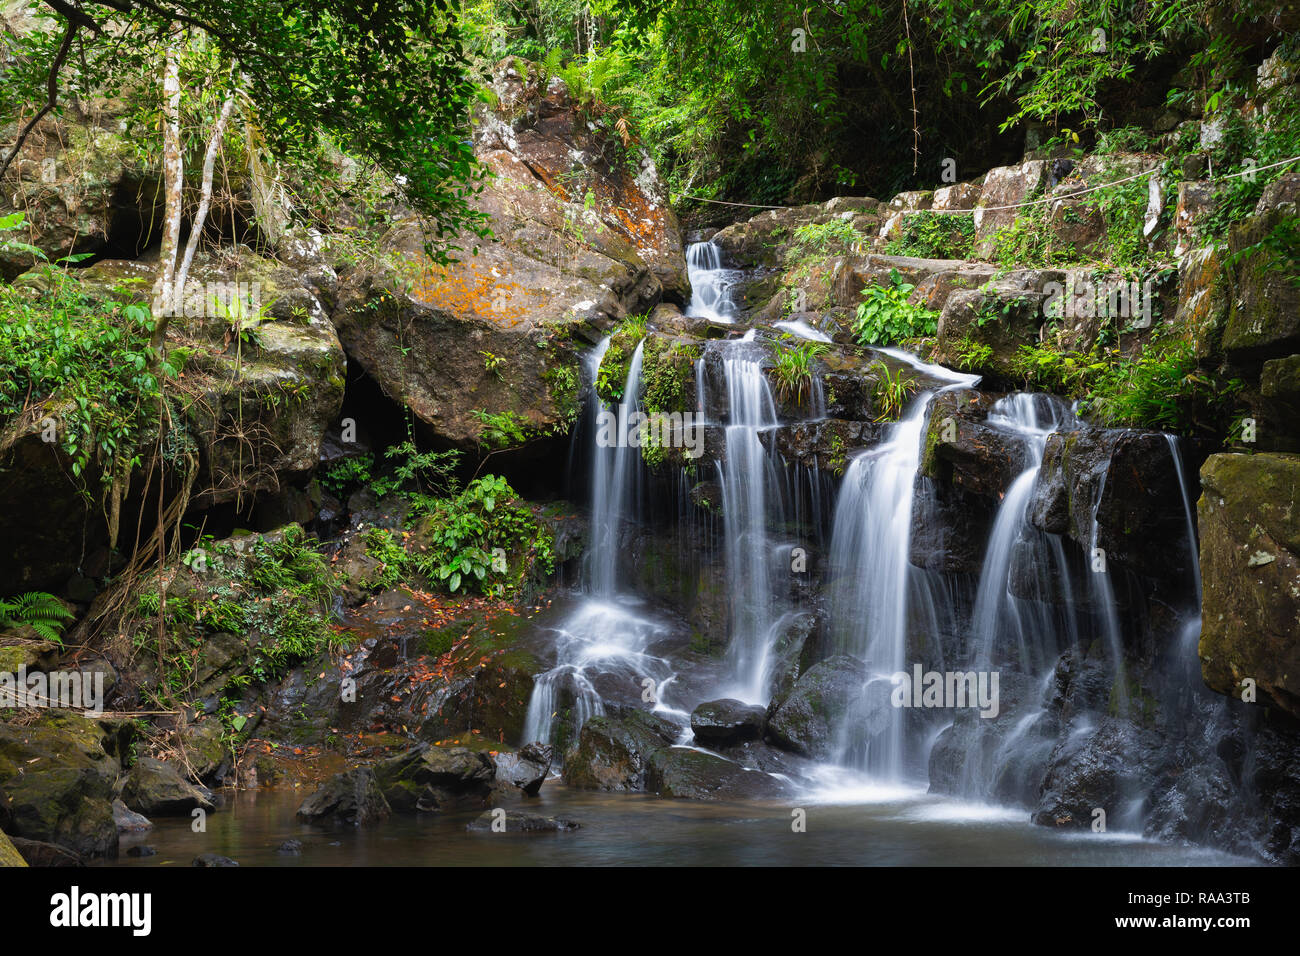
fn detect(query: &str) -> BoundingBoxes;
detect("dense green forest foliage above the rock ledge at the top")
[465,0,1270,204]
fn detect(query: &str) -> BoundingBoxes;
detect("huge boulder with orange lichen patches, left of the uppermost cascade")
[333,61,689,446]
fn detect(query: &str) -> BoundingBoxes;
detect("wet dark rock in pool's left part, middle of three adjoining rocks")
[374,743,497,813]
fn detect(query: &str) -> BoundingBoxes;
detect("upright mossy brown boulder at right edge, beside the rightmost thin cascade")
[1197,454,1300,717]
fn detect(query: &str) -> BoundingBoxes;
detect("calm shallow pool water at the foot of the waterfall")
[94,780,1252,866]
